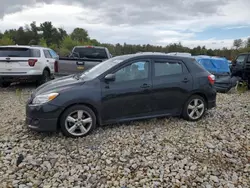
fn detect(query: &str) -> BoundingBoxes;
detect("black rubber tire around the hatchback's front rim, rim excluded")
[59,105,96,138]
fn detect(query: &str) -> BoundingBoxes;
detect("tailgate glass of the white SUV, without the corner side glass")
[0,47,31,57]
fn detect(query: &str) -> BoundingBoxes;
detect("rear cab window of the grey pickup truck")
[74,48,108,59]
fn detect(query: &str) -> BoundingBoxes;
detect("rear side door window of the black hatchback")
[154,61,183,76]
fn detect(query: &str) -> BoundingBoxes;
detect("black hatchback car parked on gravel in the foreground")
[26,53,216,137]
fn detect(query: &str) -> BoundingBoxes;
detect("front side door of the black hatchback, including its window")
[101,59,152,122]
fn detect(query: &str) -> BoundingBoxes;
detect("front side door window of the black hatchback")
[115,61,149,82]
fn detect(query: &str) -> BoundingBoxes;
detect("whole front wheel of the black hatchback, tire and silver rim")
[60,105,96,138]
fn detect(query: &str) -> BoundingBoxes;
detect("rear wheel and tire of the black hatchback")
[182,95,207,121]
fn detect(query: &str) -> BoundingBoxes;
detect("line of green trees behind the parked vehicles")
[0,22,250,60]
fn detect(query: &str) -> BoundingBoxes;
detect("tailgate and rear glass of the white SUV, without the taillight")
[0,47,41,75]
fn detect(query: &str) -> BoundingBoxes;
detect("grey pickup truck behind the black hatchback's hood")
[56,46,112,76]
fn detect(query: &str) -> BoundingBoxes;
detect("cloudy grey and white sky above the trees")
[0,0,250,49]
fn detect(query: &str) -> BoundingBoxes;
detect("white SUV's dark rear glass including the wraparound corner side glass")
[0,47,41,57]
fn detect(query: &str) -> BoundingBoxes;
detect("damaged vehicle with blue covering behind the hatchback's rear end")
[194,55,234,92]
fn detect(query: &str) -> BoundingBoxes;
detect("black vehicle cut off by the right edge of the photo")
[231,53,250,80]
